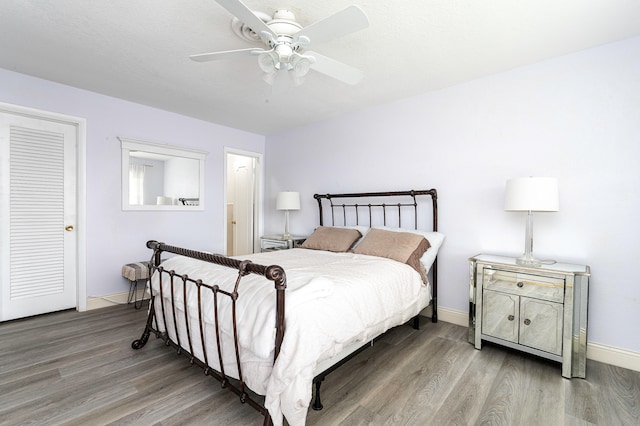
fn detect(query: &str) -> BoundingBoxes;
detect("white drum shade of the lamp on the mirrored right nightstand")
[504,177,560,212]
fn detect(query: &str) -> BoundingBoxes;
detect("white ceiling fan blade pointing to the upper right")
[296,5,369,44]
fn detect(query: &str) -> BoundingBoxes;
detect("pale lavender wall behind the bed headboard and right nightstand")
[265,38,640,352]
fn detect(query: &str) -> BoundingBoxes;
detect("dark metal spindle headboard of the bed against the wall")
[313,189,438,231]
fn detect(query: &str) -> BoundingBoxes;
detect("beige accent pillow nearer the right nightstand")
[353,228,431,284]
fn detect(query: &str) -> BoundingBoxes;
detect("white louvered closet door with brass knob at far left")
[0,112,77,321]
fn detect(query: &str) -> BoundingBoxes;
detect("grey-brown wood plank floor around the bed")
[0,305,640,426]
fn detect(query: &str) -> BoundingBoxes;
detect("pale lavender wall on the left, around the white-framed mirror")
[0,69,265,297]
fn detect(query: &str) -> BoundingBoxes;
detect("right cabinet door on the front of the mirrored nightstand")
[519,297,563,355]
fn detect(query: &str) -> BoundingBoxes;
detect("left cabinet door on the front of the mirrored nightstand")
[482,290,520,343]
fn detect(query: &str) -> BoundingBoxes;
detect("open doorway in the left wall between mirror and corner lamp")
[225,148,262,256]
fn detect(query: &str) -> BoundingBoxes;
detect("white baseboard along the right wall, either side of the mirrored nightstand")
[428,307,640,371]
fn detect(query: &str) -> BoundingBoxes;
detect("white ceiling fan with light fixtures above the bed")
[190,0,369,89]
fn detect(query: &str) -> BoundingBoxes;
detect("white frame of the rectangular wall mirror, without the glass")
[118,136,207,211]
